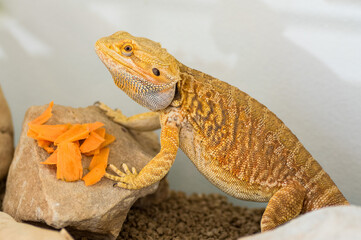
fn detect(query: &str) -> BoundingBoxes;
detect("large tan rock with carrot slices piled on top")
[3,105,160,238]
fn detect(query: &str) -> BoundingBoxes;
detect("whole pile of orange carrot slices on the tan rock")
[27,102,115,186]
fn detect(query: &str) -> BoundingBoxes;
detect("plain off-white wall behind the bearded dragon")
[0,0,361,206]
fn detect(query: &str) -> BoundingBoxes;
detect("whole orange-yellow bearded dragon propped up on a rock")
[95,32,349,231]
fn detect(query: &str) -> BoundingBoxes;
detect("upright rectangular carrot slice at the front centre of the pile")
[56,142,83,182]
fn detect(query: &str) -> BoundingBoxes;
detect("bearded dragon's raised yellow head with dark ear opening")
[95,32,180,111]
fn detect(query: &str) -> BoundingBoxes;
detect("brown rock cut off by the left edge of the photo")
[0,87,14,180]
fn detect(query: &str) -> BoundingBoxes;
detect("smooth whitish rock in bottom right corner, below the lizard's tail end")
[240,206,361,240]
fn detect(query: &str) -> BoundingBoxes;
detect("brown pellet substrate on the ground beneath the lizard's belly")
[118,191,264,240]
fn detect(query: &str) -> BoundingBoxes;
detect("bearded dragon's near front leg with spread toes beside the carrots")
[105,120,179,189]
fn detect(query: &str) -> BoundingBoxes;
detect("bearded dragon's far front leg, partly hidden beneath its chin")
[95,102,160,131]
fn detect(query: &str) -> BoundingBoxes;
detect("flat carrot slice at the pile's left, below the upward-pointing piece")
[29,124,71,142]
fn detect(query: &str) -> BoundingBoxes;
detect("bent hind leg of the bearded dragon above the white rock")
[261,182,306,232]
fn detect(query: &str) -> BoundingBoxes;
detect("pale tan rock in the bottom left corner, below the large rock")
[0,212,73,240]
